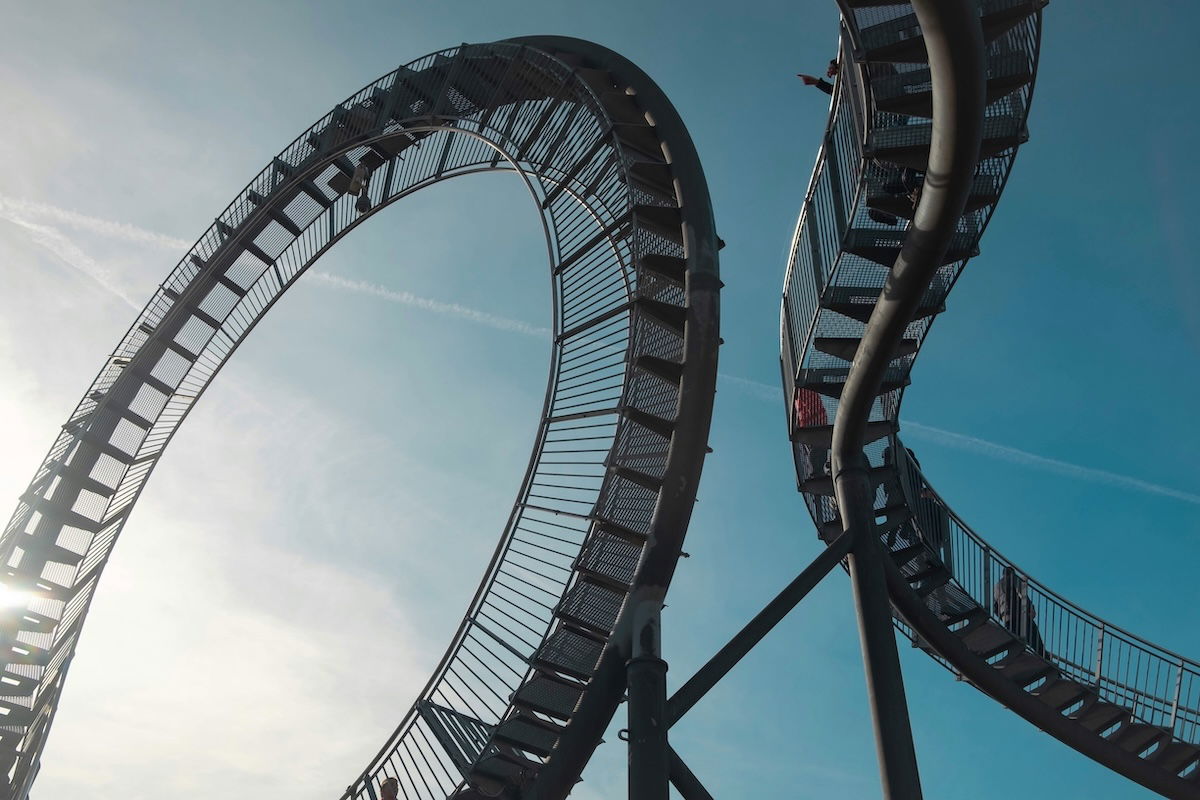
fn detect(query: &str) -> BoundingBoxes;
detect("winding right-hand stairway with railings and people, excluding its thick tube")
[780,0,1200,798]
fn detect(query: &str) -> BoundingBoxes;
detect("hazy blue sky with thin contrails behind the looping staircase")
[0,0,1200,800]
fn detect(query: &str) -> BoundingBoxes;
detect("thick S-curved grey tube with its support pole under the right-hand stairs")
[832,0,985,799]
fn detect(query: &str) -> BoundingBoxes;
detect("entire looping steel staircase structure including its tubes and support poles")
[0,0,1200,800]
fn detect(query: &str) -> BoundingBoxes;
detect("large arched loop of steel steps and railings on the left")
[0,38,720,800]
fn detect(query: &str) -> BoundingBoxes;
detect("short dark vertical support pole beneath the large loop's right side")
[625,594,671,800]
